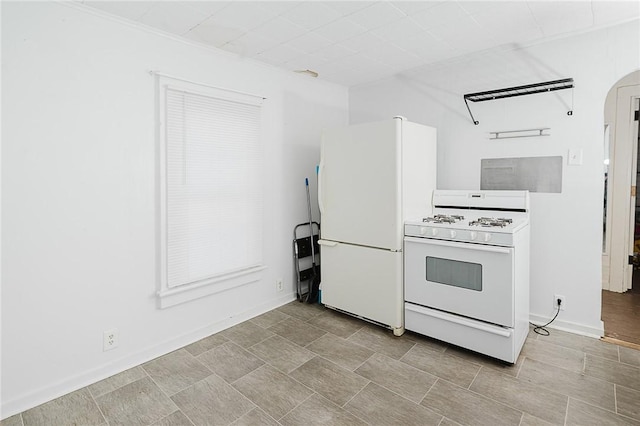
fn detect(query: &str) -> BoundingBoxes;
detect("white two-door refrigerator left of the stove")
[318,117,436,336]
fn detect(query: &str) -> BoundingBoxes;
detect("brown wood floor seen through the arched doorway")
[602,288,640,345]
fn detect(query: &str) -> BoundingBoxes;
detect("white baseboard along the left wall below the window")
[0,293,296,419]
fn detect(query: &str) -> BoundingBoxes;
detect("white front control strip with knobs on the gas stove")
[404,224,513,247]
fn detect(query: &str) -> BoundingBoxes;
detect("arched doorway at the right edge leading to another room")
[602,71,640,345]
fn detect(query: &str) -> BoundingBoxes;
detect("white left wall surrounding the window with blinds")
[0,2,348,418]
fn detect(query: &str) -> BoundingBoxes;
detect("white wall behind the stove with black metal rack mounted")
[350,20,640,335]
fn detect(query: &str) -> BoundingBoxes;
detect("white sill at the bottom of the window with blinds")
[157,266,266,309]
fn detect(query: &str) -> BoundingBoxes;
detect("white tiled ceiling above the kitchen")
[78,0,640,86]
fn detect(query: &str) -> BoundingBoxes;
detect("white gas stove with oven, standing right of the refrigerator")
[404,190,529,363]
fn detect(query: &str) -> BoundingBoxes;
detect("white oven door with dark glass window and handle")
[404,237,514,327]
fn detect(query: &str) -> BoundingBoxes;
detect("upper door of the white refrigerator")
[318,119,402,250]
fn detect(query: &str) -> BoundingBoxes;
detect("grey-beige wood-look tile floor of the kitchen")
[1,302,640,426]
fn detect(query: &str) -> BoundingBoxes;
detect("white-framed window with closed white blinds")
[158,76,263,307]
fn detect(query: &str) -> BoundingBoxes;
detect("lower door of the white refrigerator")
[320,239,404,335]
